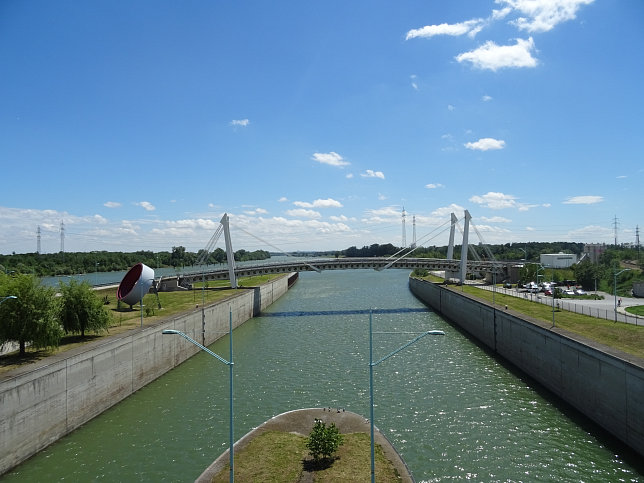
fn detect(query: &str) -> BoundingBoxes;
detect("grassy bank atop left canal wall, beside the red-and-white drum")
[0,275,282,373]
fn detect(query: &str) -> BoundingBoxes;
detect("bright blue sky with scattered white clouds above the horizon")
[0,0,644,253]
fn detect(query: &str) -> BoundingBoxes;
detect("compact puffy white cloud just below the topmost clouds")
[456,37,537,71]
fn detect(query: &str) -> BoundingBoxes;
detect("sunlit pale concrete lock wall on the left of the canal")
[0,274,297,475]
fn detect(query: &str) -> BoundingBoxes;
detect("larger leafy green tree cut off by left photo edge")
[0,274,63,356]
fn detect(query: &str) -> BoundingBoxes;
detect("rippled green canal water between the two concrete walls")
[3,270,644,482]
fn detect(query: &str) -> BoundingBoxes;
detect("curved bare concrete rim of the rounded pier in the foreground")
[195,408,414,483]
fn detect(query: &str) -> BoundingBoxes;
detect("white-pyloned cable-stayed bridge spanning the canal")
[178,210,516,288]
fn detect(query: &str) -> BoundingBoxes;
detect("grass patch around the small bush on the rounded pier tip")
[212,431,400,483]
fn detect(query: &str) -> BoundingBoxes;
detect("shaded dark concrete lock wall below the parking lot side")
[409,278,644,455]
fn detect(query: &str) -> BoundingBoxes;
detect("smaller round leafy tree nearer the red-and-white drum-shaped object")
[60,280,110,337]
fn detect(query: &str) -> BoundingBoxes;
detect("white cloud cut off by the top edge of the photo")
[496,0,594,32]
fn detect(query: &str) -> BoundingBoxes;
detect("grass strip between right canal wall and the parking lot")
[416,276,644,358]
